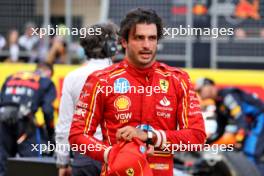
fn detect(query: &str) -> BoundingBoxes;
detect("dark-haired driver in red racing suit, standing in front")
[69,9,205,176]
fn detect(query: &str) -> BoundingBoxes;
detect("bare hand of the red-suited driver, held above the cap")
[116,126,148,142]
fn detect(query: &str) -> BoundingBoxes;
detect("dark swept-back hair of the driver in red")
[119,8,163,41]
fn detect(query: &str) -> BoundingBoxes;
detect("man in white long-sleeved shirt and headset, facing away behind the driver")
[56,23,118,176]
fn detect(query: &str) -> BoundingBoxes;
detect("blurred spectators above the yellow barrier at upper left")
[0,22,71,64]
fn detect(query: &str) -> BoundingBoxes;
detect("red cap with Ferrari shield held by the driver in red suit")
[108,138,153,176]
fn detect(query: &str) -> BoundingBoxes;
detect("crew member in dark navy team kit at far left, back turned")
[0,63,56,176]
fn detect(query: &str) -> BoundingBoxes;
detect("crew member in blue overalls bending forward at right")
[196,78,264,174]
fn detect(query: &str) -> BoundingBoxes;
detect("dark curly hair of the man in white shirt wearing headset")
[80,22,118,59]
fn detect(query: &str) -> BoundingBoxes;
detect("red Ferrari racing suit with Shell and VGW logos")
[69,58,206,176]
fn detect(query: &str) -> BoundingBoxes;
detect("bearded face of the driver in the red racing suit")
[122,23,158,68]
